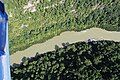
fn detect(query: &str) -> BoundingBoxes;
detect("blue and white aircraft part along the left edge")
[0,1,11,80]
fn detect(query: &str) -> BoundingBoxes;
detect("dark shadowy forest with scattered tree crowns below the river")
[11,41,120,80]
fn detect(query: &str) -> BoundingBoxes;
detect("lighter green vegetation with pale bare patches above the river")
[5,0,120,54]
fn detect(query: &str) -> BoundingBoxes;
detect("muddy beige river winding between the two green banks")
[10,28,120,64]
